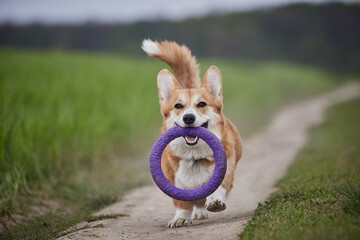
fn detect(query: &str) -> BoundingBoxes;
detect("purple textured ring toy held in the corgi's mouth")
[150,126,227,201]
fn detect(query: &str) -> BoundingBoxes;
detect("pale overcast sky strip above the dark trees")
[0,0,360,24]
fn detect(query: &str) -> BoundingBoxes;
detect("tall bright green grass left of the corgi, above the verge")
[0,50,160,216]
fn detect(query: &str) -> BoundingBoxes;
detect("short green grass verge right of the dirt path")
[240,99,360,240]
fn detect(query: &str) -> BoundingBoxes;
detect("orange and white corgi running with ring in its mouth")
[142,39,242,228]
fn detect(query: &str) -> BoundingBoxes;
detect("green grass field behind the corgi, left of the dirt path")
[0,49,336,238]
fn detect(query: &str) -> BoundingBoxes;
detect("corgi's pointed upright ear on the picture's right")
[201,66,222,99]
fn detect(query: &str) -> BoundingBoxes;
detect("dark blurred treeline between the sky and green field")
[0,3,360,73]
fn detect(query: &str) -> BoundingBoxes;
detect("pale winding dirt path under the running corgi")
[61,83,360,240]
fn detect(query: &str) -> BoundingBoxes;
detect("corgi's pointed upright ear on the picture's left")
[157,69,180,103]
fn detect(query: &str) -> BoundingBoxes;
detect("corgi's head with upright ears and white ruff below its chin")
[157,66,224,160]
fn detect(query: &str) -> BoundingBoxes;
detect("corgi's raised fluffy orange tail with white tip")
[141,39,200,88]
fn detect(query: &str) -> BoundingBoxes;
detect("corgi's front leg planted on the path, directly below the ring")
[168,199,193,228]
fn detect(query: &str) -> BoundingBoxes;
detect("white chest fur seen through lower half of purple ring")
[175,160,215,189]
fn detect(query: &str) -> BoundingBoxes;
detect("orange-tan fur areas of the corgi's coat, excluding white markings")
[145,41,242,225]
